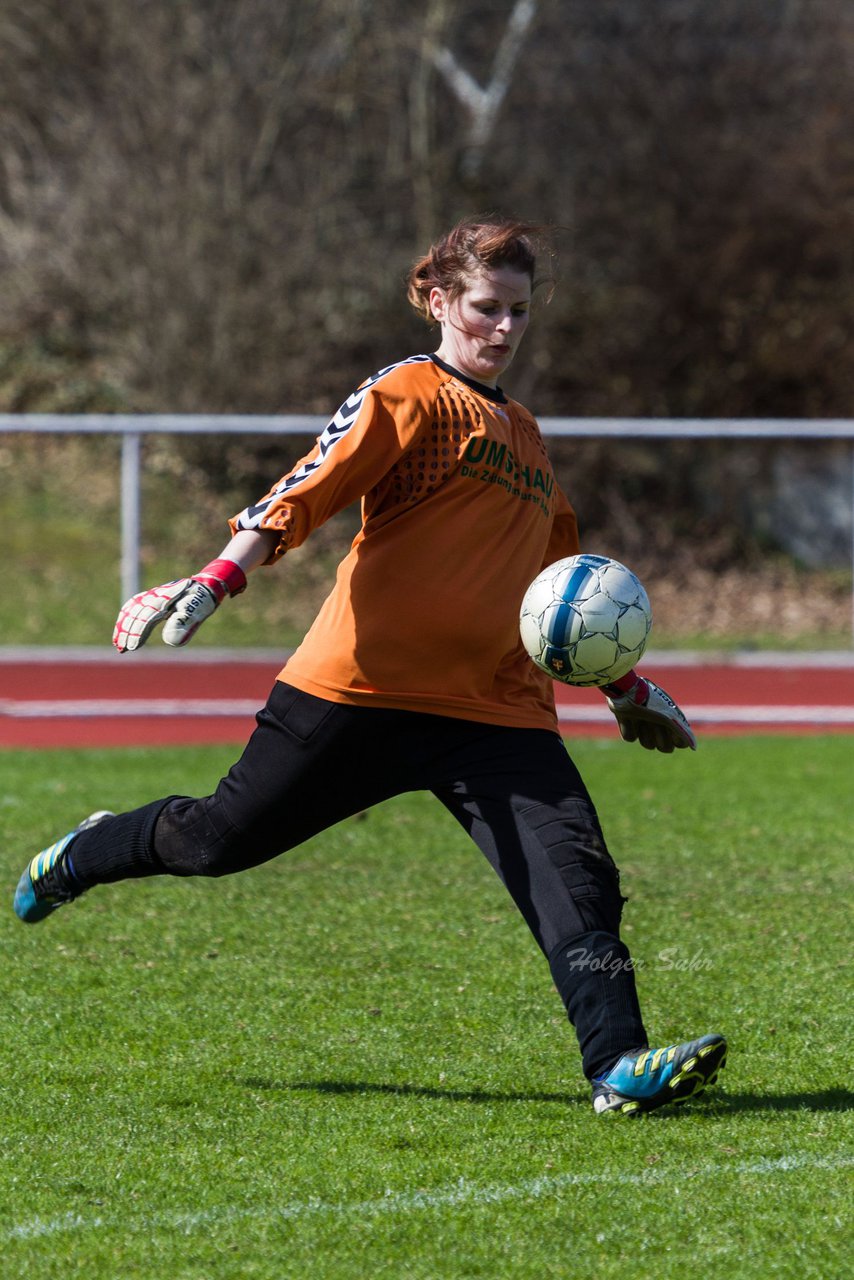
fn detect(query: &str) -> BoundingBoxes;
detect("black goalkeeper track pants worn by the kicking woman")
[72,682,647,1076]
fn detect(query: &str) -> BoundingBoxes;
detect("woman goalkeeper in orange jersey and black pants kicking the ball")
[15,220,726,1115]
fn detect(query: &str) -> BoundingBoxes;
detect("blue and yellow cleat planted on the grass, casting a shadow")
[593,1036,726,1116]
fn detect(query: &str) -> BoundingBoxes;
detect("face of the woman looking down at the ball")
[430,266,531,387]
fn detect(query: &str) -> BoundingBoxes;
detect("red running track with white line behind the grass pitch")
[0,649,854,749]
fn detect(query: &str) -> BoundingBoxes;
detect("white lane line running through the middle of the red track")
[0,698,854,726]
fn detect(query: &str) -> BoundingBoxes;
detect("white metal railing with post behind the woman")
[0,413,854,636]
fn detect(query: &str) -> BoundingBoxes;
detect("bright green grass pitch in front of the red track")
[0,737,854,1280]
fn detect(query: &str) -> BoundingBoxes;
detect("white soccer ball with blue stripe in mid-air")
[519,556,652,686]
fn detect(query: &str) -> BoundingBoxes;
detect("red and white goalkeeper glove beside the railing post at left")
[113,559,246,653]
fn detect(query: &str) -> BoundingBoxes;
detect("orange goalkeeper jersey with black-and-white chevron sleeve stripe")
[230,356,579,730]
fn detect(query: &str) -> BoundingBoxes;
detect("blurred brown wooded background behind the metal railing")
[0,0,854,622]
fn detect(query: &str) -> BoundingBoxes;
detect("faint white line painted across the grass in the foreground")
[8,1152,854,1240]
